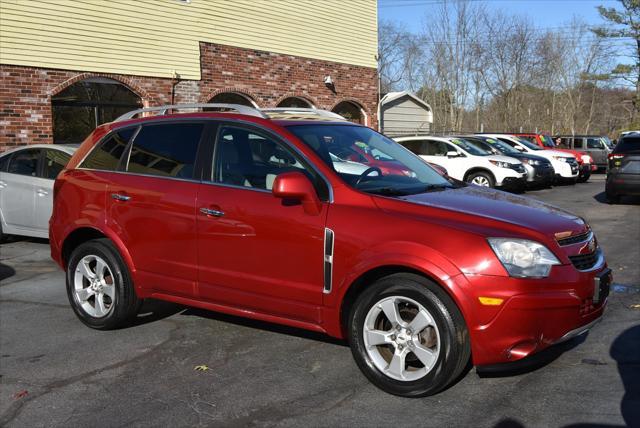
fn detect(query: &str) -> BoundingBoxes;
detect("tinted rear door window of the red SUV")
[127,123,204,178]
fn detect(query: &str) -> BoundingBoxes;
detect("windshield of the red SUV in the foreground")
[287,124,457,196]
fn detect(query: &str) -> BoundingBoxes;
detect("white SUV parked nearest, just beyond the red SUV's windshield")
[395,136,526,190]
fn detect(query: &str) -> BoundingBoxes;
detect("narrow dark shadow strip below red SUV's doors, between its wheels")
[182,308,349,346]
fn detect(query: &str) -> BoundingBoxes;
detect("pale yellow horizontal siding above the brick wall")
[0,0,377,79]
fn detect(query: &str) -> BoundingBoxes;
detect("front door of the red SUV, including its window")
[197,125,328,323]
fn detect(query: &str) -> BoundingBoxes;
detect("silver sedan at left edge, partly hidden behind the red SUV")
[0,144,78,238]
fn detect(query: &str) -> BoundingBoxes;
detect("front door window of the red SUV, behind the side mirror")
[214,127,313,190]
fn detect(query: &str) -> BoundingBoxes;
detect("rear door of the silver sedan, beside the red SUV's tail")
[34,149,71,234]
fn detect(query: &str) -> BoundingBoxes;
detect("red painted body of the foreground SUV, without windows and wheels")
[50,113,607,365]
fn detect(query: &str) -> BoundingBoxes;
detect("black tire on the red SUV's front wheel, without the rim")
[348,273,471,397]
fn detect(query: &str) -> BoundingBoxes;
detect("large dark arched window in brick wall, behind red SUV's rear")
[51,77,142,144]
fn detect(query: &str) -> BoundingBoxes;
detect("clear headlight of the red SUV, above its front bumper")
[488,238,560,278]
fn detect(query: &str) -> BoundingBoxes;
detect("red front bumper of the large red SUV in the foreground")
[465,259,611,366]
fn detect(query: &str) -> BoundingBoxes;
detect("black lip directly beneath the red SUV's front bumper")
[476,333,589,378]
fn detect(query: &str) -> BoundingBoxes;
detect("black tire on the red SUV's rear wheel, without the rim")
[66,239,142,330]
